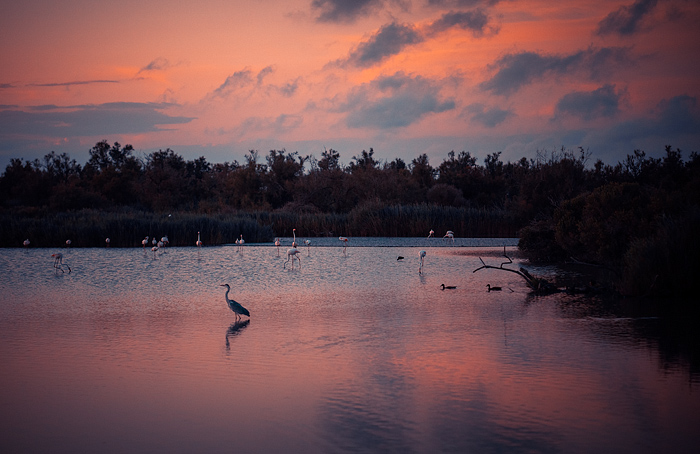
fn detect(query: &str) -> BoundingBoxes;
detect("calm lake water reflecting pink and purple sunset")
[0,239,700,453]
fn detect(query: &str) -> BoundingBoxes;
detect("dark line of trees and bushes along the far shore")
[0,141,700,293]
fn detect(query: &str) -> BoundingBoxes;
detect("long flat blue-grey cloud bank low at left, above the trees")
[0,102,194,138]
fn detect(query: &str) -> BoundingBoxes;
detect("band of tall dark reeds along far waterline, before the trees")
[0,202,518,247]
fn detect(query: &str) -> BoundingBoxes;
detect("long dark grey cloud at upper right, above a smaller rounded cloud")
[480,47,632,96]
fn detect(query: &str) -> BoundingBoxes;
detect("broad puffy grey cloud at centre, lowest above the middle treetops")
[340,72,455,129]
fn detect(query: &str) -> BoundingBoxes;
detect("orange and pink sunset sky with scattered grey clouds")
[0,0,700,171]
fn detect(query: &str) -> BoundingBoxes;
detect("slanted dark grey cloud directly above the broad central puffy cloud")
[348,22,424,68]
